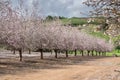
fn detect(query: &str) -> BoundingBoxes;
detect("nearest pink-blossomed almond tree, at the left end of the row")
[0,0,41,61]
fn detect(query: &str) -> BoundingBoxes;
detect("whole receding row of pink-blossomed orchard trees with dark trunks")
[0,18,113,61]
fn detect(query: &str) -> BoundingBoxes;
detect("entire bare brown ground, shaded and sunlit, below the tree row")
[0,50,120,80]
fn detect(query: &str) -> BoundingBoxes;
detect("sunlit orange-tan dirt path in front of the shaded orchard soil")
[0,57,120,80]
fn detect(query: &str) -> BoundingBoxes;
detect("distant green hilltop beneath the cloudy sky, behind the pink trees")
[46,15,104,27]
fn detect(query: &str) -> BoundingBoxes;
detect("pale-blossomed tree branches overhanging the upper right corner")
[83,0,120,44]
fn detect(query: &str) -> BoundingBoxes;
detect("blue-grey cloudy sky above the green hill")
[12,0,90,17]
